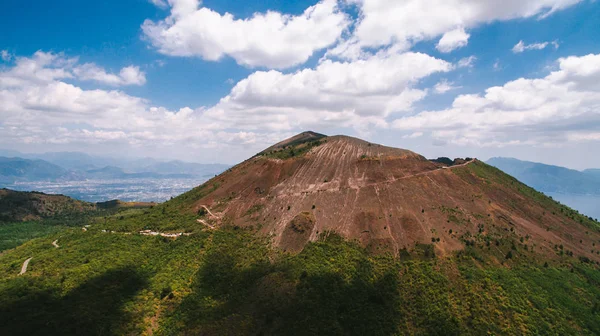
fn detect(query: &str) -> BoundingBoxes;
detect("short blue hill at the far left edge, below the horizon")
[0,157,73,183]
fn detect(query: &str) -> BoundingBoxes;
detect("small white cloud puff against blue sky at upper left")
[73,63,146,86]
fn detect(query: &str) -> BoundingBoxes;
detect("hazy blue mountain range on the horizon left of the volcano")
[0,150,229,184]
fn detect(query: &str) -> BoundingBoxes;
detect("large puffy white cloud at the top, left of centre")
[142,0,350,69]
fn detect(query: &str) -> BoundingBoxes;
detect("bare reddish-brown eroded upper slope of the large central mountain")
[176,132,600,260]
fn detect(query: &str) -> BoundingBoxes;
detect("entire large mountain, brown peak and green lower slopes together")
[0,132,600,336]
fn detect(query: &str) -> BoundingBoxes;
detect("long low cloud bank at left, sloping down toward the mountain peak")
[0,51,280,156]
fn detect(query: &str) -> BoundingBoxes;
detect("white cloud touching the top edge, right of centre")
[329,0,582,59]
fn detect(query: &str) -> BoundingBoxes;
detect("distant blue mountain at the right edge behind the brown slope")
[487,158,600,195]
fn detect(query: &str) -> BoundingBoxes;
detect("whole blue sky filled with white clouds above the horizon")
[0,0,600,169]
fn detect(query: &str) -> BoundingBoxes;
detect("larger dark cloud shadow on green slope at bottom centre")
[164,250,400,335]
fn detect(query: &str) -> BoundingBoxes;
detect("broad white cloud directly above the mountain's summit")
[206,51,453,131]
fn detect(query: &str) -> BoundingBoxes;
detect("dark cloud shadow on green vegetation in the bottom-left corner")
[0,268,147,335]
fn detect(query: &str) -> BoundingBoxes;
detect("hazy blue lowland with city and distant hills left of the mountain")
[0,150,229,202]
